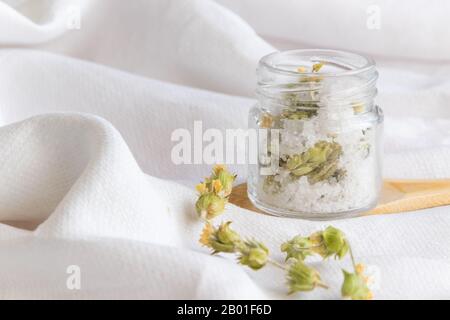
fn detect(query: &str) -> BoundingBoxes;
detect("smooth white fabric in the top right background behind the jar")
[217,0,450,61]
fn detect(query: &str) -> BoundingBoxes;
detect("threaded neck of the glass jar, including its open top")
[256,50,378,115]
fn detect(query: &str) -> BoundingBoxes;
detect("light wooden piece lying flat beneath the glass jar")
[229,179,450,215]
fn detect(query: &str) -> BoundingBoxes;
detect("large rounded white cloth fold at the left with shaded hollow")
[0,114,182,244]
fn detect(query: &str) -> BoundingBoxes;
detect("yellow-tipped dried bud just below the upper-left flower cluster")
[200,221,241,254]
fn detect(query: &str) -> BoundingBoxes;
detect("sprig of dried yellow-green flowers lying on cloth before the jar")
[195,165,373,300]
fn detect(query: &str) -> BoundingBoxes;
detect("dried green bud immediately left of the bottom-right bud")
[287,260,326,294]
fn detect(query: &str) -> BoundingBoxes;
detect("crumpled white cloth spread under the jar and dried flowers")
[0,0,450,299]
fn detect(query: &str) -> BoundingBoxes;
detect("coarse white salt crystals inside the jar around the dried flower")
[258,122,379,213]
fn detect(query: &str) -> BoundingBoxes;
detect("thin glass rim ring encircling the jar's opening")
[259,49,375,77]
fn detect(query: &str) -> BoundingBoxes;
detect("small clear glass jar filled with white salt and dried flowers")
[248,50,383,219]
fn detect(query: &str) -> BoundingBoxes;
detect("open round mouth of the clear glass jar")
[259,49,375,77]
